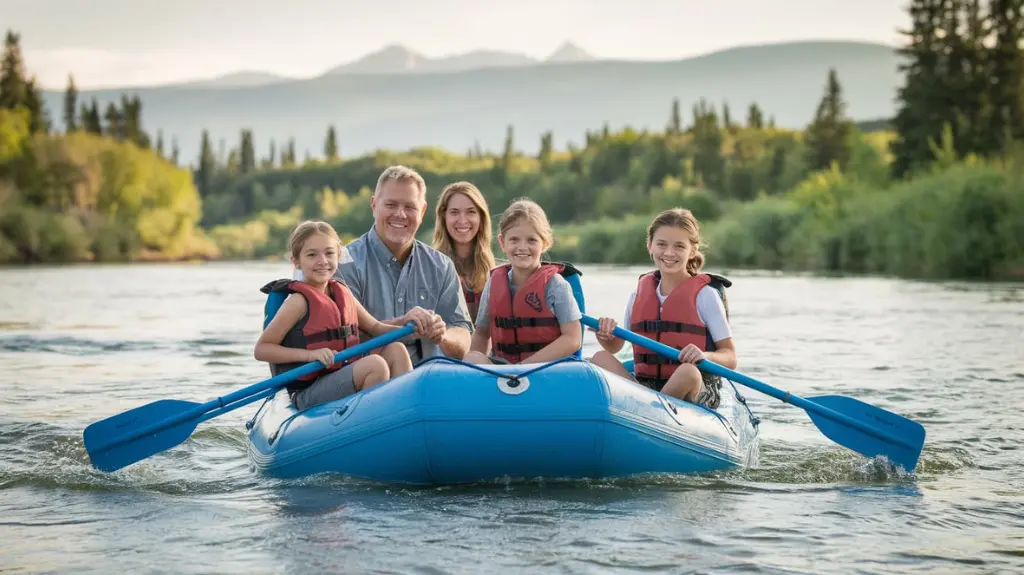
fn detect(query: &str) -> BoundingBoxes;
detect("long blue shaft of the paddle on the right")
[582,315,918,449]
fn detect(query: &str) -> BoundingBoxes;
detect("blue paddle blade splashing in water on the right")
[806,395,925,472]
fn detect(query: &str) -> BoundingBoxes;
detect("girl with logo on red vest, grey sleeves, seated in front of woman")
[464,200,583,363]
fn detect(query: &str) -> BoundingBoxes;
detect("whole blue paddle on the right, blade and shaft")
[583,315,925,472]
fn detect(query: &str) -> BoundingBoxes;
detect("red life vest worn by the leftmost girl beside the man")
[261,279,359,392]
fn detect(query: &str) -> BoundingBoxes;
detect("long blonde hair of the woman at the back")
[433,182,495,292]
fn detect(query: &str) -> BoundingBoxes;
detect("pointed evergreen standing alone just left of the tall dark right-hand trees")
[806,69,853,170]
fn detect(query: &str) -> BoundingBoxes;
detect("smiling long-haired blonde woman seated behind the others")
[433,182,495,321]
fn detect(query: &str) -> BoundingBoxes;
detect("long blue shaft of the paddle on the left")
[93,323,416,451]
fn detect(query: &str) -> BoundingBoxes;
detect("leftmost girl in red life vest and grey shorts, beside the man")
[253,216,432,410]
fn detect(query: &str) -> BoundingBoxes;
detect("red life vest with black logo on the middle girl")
[487,263,564,363]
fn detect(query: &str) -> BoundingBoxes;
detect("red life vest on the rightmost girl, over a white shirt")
[630,271,731,380]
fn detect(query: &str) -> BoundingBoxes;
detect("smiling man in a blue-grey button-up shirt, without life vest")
[335,166,473,363]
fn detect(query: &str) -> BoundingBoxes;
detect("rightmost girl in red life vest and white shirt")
[591,208,736,409]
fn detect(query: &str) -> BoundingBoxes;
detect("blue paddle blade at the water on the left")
[82,399,200,472]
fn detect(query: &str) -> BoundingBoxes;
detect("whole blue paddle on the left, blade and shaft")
[82,323,415,472]
